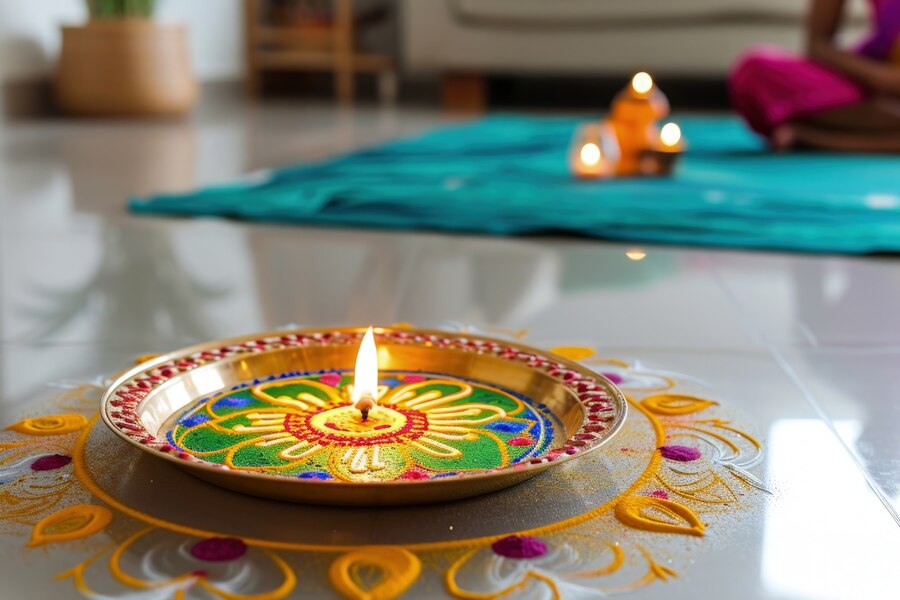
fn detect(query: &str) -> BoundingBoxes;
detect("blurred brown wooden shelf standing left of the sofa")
[244,0,396,102]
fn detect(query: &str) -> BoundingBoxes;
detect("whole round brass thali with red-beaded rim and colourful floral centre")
[101,327,627,505]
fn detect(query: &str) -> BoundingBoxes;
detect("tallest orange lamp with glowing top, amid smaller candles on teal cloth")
[609,72,669,175]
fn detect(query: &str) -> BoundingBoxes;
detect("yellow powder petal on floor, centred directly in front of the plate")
[328,546,422,600]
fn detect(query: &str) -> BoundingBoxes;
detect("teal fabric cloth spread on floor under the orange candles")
[130,116,900,254]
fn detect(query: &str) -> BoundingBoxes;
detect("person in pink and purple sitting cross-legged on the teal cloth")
[730,0,900,152]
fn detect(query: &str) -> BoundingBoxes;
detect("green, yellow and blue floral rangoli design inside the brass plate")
[166,371,558,481]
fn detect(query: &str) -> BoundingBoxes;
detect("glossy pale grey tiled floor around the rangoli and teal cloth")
[0,96,900,598]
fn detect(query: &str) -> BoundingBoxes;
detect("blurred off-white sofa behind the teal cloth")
[402,0,866,76]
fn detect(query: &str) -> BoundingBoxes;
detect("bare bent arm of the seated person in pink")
[806,0,900,96]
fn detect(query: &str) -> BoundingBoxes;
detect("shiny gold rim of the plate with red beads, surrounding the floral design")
[101,327,627,505]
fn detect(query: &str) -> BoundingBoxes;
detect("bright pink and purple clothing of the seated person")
[730,0,900,137]
